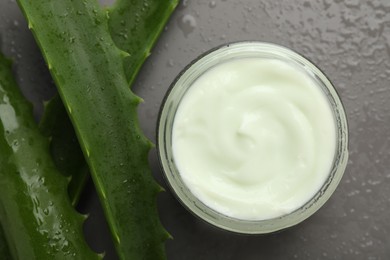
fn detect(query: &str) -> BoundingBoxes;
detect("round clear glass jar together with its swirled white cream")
[157,42,348,234]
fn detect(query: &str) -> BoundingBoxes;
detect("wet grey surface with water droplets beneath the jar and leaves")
[0,0,390,260]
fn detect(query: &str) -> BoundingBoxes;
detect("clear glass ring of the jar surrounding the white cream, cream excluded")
[157,42,348,234]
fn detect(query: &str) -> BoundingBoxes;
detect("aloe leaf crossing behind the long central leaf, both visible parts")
[36,0,178,209]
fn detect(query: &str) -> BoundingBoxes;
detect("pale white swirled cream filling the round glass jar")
[172,58,336,220]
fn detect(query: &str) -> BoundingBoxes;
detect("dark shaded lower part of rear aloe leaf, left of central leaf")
[39,95,89,206]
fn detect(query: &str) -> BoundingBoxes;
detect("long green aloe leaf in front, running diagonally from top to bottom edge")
[18,0,169,259]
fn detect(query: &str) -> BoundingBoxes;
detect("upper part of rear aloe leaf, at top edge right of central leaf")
[108,0,179,85]
